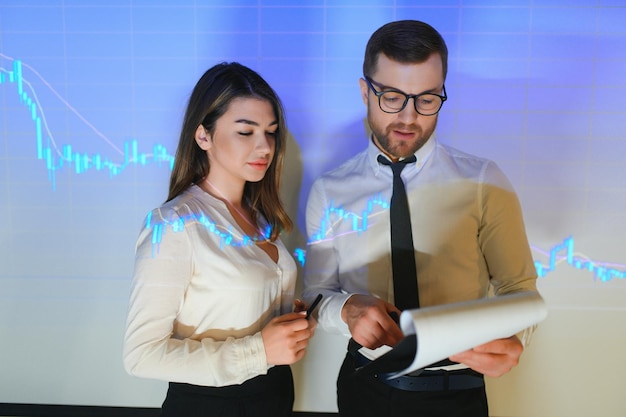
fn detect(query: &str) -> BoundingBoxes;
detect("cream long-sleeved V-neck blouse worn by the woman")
[124,185,297,386]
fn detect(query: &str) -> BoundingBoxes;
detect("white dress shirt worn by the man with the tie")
[303,136,537,336]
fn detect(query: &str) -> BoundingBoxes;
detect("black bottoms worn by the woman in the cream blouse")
[161,366,294,417]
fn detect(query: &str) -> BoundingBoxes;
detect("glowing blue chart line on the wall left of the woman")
[0,53,174,190]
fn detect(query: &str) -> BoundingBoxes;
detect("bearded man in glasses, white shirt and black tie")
[304,20,537,417]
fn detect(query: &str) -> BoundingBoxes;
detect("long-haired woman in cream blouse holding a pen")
[124,63,315,417]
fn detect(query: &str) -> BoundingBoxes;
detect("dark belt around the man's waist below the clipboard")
[349,340,485,391]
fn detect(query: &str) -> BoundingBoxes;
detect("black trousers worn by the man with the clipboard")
[337,353,489,417]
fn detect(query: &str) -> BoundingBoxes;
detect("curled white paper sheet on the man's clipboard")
[361,292,547,378]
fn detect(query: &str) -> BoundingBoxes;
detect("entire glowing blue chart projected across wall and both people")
[0,53,626,282]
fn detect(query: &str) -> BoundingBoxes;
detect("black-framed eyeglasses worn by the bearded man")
[363,76,448,116]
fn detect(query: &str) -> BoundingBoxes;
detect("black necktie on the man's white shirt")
[378,155,419,310]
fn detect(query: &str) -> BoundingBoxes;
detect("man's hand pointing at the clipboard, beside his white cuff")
[341,294,404,349]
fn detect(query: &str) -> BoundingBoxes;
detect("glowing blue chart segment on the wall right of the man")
[533,236,626,282]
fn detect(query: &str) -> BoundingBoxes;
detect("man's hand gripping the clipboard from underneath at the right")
[450,336,524,377]
